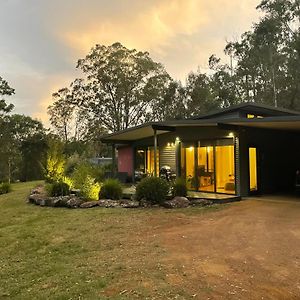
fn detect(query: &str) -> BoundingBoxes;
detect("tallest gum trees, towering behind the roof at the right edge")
[225,0,300,109]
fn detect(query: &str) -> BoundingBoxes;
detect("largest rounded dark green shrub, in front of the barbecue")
[136,177,170,204]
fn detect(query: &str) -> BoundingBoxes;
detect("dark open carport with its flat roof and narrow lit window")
[219,116,300,196]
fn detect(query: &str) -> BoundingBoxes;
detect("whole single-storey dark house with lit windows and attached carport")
[101,103,300,196]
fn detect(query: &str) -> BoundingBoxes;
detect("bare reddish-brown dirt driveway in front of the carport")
[157,200,300,299]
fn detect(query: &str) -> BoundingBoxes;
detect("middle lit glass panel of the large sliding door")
[197,146,215,192]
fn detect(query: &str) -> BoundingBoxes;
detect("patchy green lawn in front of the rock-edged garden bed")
[0,182,225,300]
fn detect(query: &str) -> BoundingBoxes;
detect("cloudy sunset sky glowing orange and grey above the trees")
[0,0,260,126]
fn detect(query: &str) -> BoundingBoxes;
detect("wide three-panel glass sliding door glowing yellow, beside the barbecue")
[181,139,236,194]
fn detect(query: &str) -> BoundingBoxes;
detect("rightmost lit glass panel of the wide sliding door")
[216,146,235,194]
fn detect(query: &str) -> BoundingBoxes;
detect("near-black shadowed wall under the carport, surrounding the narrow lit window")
[239,129,300,196]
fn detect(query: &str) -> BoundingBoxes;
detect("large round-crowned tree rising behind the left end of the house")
[77,43,171,131]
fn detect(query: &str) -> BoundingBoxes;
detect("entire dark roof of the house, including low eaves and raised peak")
[101,103,300,144]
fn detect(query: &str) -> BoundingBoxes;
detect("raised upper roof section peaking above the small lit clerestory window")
[191,102,300,120]
